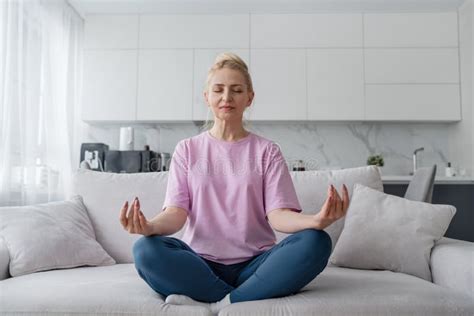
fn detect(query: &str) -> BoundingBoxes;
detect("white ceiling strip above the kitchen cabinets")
[67,0,470,17]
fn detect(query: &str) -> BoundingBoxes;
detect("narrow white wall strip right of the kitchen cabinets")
[449,0,474,175]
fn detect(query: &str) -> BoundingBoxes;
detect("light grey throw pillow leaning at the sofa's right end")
[330,184,456,281]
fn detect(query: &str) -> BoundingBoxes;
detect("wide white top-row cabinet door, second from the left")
[139,14,250,49]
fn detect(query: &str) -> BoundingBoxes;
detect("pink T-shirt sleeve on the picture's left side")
[162,141,190,213]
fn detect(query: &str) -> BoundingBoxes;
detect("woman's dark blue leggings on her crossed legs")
[133,229,331,303]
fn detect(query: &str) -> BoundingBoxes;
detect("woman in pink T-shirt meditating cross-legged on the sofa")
[120,53,349,313]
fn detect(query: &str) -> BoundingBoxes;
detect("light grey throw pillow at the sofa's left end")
[0,196,115,277]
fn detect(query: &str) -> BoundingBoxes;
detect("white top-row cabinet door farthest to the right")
[364,12,458,47]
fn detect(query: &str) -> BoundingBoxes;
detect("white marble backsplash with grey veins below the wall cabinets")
[82,122,468,175]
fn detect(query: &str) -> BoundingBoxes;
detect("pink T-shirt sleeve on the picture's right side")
[263,143,301,214]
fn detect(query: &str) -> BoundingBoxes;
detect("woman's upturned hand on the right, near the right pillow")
[314,184,349,230]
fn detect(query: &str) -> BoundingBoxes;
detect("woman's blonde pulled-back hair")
[201,52,254,130]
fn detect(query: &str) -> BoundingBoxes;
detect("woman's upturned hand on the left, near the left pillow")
[120,197,153,236]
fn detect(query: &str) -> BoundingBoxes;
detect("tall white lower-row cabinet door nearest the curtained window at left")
[82,50,137,121]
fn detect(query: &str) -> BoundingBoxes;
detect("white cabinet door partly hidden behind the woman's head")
[193,49,250,121]
